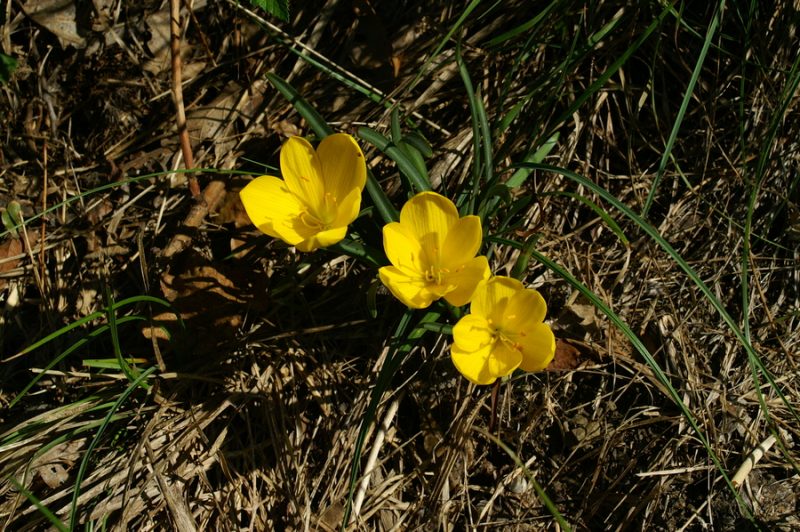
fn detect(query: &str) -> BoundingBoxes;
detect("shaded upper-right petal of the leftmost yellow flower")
[317,133,367,202]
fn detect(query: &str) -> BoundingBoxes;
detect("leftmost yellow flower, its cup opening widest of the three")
[239,133,367,251]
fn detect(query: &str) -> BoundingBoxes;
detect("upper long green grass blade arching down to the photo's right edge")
[520,163,800,422]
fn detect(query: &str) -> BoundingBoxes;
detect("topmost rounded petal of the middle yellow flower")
[400,192,458,264]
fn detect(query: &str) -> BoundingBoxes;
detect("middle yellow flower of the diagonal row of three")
[378,192,490,308]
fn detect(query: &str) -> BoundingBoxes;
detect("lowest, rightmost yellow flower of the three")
[450,276,556,384]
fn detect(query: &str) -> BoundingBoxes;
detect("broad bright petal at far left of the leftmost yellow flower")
[239,175,310,245]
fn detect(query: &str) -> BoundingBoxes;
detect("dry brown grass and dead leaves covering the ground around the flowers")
[0,0,800,530]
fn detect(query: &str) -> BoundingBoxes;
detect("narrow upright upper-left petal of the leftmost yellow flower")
[281,137,322,216]
